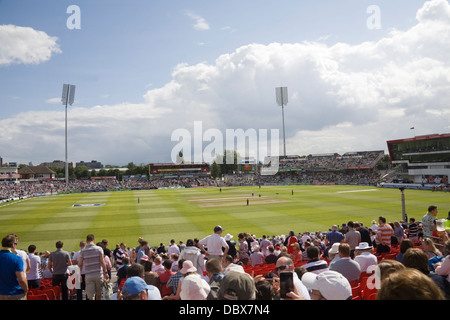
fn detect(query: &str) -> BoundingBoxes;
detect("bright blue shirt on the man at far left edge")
[0,250,24,295]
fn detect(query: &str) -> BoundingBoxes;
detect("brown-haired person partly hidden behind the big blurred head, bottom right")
[403,248,450,299]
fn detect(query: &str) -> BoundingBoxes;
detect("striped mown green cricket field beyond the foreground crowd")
[0,186,450,251]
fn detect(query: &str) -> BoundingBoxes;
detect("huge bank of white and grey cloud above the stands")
[0,0,450,164]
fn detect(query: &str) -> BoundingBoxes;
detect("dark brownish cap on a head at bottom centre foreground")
[218,271,256,300]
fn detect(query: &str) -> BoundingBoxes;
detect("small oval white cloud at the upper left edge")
[0,25,61,66]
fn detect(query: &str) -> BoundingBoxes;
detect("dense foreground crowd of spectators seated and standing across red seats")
[0,206,450,300]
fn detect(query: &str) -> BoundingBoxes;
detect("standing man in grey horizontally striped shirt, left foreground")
[78,234,108,300]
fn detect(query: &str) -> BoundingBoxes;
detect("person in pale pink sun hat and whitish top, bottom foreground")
[180,260,210,300]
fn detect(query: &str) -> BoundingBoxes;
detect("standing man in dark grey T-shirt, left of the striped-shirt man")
[48,241,72,300]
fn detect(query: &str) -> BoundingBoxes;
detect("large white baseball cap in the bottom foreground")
[302,270,352,300]
